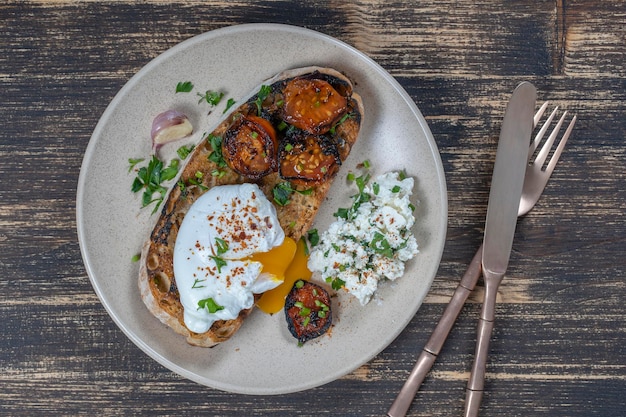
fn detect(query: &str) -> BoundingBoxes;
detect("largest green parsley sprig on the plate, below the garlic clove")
[129,155,179,214]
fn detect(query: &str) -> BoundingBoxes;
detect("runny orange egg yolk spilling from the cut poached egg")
[252,237,311,314]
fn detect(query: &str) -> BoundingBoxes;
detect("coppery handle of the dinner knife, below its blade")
[464,271,504,417]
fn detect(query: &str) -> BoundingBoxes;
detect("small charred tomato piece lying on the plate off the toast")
[285,280,332,343]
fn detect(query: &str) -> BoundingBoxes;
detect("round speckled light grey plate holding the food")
[77,24,447,395]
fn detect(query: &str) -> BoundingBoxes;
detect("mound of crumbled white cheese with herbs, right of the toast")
[308,172,418,305]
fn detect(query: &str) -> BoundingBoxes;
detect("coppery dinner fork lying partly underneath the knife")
[387,101,576,417]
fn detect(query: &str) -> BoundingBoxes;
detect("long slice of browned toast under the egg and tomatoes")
[139,67,363,347]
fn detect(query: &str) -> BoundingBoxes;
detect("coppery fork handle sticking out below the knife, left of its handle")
[387,245,483,417]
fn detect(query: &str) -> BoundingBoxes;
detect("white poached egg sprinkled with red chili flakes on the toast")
[174,183,286,333]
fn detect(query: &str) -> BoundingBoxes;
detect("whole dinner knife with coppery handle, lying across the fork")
[465,82,537,417]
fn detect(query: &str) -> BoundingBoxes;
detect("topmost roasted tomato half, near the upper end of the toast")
[283,78,347,135]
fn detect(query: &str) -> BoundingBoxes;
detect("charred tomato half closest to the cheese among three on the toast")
[279,131,341,186]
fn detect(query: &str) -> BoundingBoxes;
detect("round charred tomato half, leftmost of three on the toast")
[222,115,278,180]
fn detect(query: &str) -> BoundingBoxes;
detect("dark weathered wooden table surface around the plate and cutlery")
[0,0,626,417]
